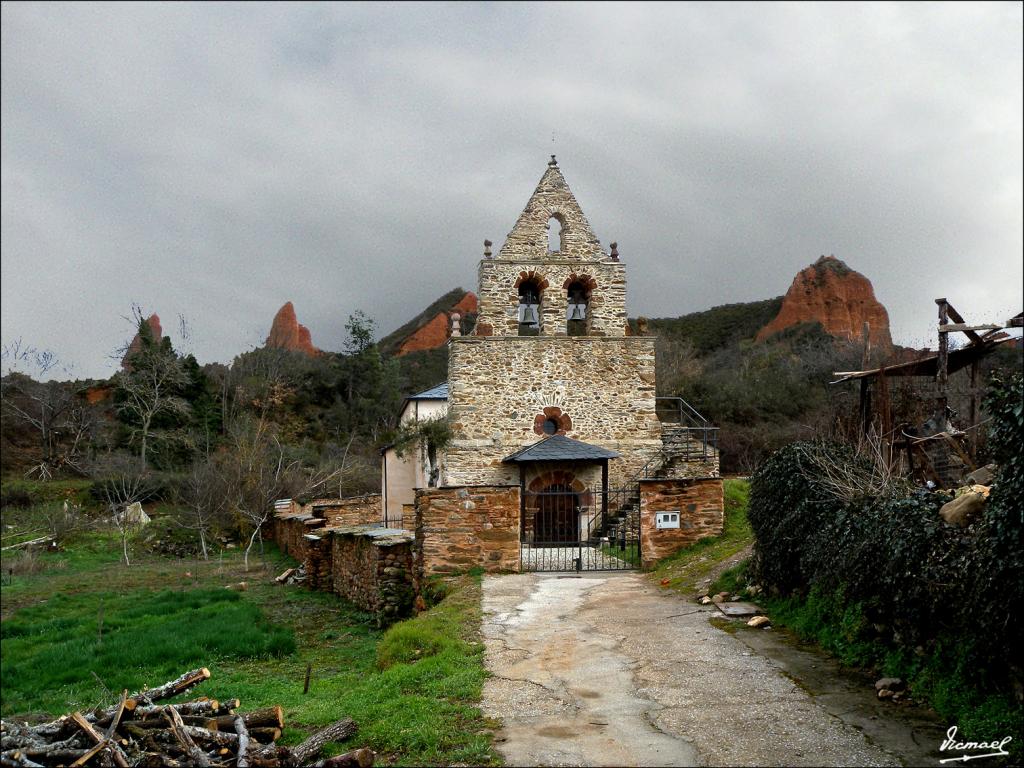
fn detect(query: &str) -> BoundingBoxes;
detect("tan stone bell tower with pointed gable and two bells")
[443,156,662,485]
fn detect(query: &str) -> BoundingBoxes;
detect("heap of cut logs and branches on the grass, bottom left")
[0,669,374,768]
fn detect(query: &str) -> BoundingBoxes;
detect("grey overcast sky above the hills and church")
[0,2,1024,377]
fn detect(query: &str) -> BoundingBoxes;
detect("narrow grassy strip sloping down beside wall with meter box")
[652,479,754,593]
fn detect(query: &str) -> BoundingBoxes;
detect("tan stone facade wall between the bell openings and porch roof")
[443,336,662,486]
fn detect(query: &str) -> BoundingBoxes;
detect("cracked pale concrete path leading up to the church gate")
[481,573,933,766]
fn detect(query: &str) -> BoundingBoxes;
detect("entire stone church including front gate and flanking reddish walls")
[382,156,722,572]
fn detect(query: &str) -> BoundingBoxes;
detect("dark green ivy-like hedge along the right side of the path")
[749,375,1024,729]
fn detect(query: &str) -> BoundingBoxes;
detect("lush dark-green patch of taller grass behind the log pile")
[0,589,295,715]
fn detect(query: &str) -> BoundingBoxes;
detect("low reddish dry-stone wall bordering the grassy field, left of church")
[273,513,415,626]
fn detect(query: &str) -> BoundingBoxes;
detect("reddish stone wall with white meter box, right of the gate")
[640,478,725,568]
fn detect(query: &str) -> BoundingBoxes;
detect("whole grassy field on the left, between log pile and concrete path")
[0,535,498,765]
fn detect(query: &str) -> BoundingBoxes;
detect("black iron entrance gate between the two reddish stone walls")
[519,484,640,571]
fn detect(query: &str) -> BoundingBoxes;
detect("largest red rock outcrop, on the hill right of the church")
[758,256,893,351]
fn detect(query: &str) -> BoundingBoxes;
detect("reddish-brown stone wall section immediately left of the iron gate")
[416,486,519,575]
